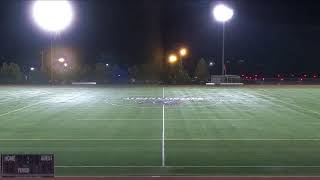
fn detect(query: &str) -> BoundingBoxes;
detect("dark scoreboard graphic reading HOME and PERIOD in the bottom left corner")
[1,154,54,177]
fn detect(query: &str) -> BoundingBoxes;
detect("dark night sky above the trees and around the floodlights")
[0,0,320,73]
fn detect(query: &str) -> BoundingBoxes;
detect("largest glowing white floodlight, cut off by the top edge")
[32,0,73,32]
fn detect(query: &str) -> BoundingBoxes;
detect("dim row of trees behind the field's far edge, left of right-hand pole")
[0,59,209,84]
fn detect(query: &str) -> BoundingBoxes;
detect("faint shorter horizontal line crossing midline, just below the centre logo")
[76,118,251,121]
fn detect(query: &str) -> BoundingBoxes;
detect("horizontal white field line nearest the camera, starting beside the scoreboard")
[55,165,320,168]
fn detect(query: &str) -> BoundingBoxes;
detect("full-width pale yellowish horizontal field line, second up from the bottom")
[0,138,320,141]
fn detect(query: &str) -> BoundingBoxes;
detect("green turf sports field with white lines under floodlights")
[0,86,320,175]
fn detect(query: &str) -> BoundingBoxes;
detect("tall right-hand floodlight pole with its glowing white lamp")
[213,4,233,75]
